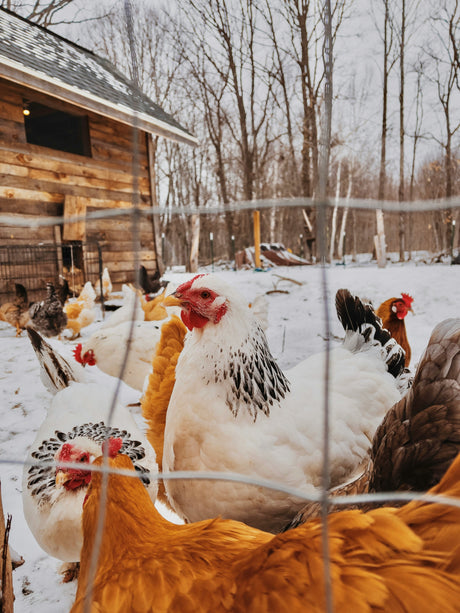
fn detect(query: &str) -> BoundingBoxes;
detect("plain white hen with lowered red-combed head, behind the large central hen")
[74,312,161,391]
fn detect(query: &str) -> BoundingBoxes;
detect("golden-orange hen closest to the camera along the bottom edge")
[70,448,460,613]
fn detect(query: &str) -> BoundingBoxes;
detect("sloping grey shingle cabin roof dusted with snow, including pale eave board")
[0,8,197,145]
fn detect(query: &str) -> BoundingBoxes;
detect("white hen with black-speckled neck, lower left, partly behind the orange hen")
[22,330,157,562]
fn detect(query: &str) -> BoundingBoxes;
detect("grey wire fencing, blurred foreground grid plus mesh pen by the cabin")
[0,1,460,613]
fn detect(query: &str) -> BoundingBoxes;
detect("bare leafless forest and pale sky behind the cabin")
[1,0,460,269]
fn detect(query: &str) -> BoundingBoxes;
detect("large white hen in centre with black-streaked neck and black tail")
[161,275,404,532]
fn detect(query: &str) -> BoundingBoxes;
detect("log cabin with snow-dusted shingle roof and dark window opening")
[0,9,196,299]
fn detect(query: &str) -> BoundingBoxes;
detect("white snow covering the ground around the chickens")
[0,262,460,613]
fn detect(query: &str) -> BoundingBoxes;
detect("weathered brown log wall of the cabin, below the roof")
[0,79,156,289]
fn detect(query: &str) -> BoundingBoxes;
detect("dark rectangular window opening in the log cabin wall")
[24,101,91,157]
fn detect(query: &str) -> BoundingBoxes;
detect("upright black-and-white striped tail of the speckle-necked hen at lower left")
[27,327,81,394]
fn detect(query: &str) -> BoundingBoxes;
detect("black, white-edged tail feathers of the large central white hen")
[335,289,407,378]
